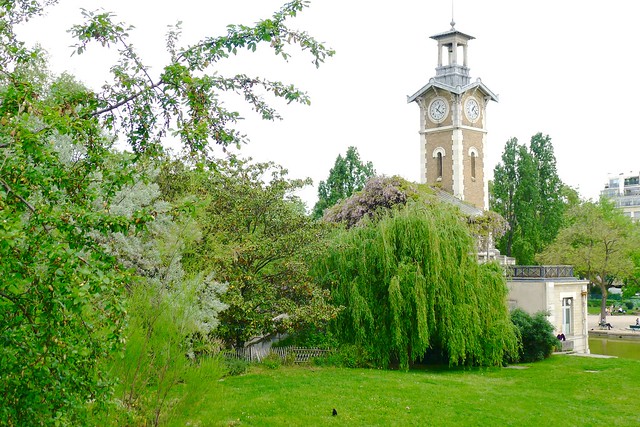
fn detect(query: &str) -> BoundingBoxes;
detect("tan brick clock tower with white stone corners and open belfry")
[407,22,498,210]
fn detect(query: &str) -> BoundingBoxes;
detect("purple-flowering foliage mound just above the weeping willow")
[323,176,420,228]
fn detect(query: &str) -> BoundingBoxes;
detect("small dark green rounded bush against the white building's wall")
[511,308,558,363]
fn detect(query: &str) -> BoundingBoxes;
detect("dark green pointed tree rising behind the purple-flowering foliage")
[313,146,376,219]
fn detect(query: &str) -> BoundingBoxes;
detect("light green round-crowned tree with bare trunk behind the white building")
[539,199,640,319]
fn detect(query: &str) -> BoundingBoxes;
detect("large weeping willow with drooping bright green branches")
[316,203,518,369]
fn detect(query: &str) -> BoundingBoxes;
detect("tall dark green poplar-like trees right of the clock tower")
[490,133,564,264]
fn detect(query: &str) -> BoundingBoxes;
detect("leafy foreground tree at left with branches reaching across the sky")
[0,0,333,425]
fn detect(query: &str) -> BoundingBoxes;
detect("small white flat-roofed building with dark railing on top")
[507,265,590,354]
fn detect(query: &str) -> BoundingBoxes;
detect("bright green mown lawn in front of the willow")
[168,355,640,427]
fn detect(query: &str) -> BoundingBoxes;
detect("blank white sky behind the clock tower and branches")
[16,0,640,207]
